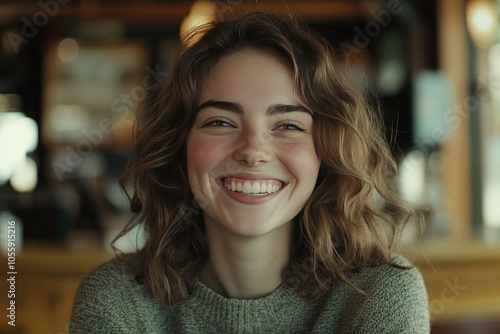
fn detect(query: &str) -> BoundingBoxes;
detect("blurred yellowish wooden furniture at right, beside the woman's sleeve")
[405,241,500,333]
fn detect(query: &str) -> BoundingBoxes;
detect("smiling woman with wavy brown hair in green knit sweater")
[71,13,429,333]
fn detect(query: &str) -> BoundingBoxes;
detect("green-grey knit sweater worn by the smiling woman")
[70,256,429,334]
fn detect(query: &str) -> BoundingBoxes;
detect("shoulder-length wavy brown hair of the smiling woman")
[116,12,418,305]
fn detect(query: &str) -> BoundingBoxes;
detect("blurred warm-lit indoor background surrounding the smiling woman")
[0,0,500,334]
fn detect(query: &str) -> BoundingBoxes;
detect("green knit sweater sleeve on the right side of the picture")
[342,259,430,334]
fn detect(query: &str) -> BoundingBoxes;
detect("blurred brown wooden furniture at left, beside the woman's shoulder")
[0,246,113,334]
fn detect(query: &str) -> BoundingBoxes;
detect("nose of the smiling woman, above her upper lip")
[233,130,272,166]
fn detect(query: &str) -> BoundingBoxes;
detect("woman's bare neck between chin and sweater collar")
[200,218,293,299]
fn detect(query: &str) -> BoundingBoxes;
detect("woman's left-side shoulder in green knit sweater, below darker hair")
[70,255,166,333]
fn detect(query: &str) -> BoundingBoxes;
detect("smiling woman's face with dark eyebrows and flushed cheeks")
[187,49,320,236]
